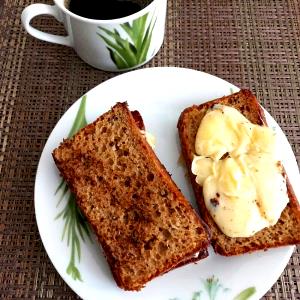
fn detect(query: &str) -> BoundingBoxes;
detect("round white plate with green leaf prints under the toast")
[35,68,300,300]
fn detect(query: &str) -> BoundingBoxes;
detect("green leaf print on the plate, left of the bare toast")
[55,96,92,281]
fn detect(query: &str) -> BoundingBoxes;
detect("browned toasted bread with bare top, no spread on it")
[53,103,209,290]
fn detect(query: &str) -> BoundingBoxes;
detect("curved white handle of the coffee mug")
[21,3,73,47]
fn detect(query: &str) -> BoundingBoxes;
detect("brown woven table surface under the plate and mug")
[0,0,300,299]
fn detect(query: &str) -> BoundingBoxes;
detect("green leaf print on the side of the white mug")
[97,14,156,70]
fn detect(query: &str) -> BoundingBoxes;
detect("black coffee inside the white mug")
[68,0,143,20]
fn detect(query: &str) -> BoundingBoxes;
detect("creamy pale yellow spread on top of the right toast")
[192,105,289,237]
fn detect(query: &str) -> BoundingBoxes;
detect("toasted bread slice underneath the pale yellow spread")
[178,90,300,256]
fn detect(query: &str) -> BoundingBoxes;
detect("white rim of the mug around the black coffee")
[54,0,161,24]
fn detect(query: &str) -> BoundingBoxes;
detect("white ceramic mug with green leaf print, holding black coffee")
[21,0,167,71]
